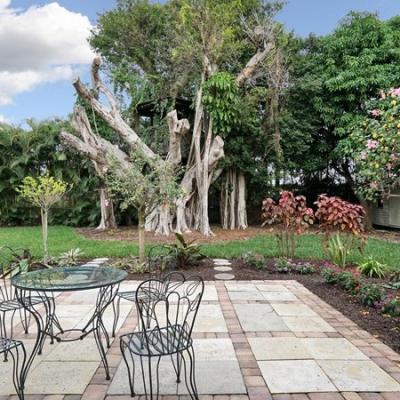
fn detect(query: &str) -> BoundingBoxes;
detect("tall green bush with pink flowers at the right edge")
[341,88,400,200]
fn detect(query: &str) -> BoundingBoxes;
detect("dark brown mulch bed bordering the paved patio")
[124,259,400,352]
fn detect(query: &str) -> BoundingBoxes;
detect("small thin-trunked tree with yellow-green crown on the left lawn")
[17,174,69,262]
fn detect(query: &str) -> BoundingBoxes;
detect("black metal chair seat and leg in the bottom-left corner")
[0,337,26,400]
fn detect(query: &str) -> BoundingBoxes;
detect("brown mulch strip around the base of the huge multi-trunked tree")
[77,226,266,243]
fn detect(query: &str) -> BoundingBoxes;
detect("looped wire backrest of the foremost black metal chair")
[136,272,204,353]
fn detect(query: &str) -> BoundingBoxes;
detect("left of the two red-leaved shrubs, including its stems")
[262,191,314,258]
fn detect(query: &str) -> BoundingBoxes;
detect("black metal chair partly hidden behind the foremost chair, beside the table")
[112,245,172,337]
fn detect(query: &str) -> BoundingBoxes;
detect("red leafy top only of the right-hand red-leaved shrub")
[315,194,365,235]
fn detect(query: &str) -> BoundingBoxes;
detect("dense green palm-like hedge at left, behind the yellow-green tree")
[0,120,100,226]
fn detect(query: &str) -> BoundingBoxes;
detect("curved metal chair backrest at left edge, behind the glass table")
[0,246,31,303]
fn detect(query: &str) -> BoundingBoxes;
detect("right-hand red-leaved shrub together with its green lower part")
[315,194,365,268]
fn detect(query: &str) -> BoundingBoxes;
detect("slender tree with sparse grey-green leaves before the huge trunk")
[106,150,181,263]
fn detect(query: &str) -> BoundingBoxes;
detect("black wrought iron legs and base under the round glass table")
[16,283,119,381]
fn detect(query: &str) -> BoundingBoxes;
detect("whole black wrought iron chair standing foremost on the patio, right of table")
[120,272,204,400]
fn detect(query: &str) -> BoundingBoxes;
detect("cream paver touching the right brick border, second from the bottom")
[300,338,368,360]
